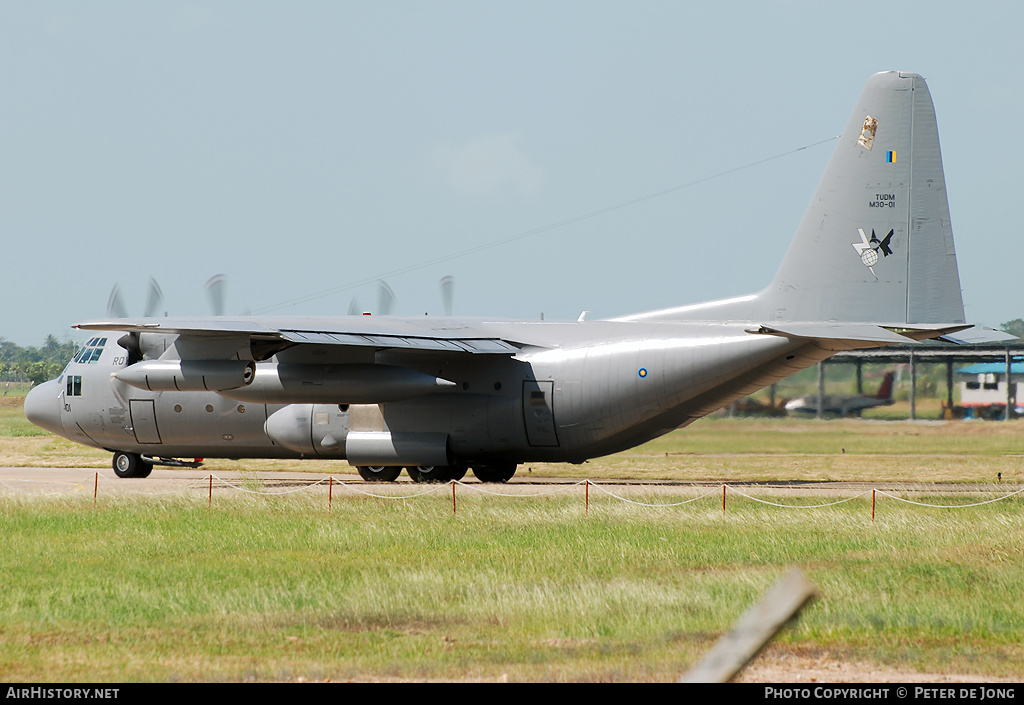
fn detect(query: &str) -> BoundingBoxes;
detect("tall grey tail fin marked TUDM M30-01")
[757,72,964,326]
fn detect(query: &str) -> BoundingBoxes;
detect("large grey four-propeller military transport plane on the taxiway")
[25,72,999,482]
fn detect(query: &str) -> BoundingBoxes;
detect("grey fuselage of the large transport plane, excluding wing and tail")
[27,321,827,464]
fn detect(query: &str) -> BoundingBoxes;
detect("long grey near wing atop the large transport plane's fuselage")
[75,317,521,355]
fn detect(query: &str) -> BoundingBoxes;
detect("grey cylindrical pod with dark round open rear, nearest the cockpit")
[114,360,256,391]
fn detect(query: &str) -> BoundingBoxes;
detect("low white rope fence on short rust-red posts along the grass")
[0,472,1024,522]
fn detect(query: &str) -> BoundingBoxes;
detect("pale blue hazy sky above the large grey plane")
[0,0,1024,344]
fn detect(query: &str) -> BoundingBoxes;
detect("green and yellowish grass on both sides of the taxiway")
[0,399,1024,681]
